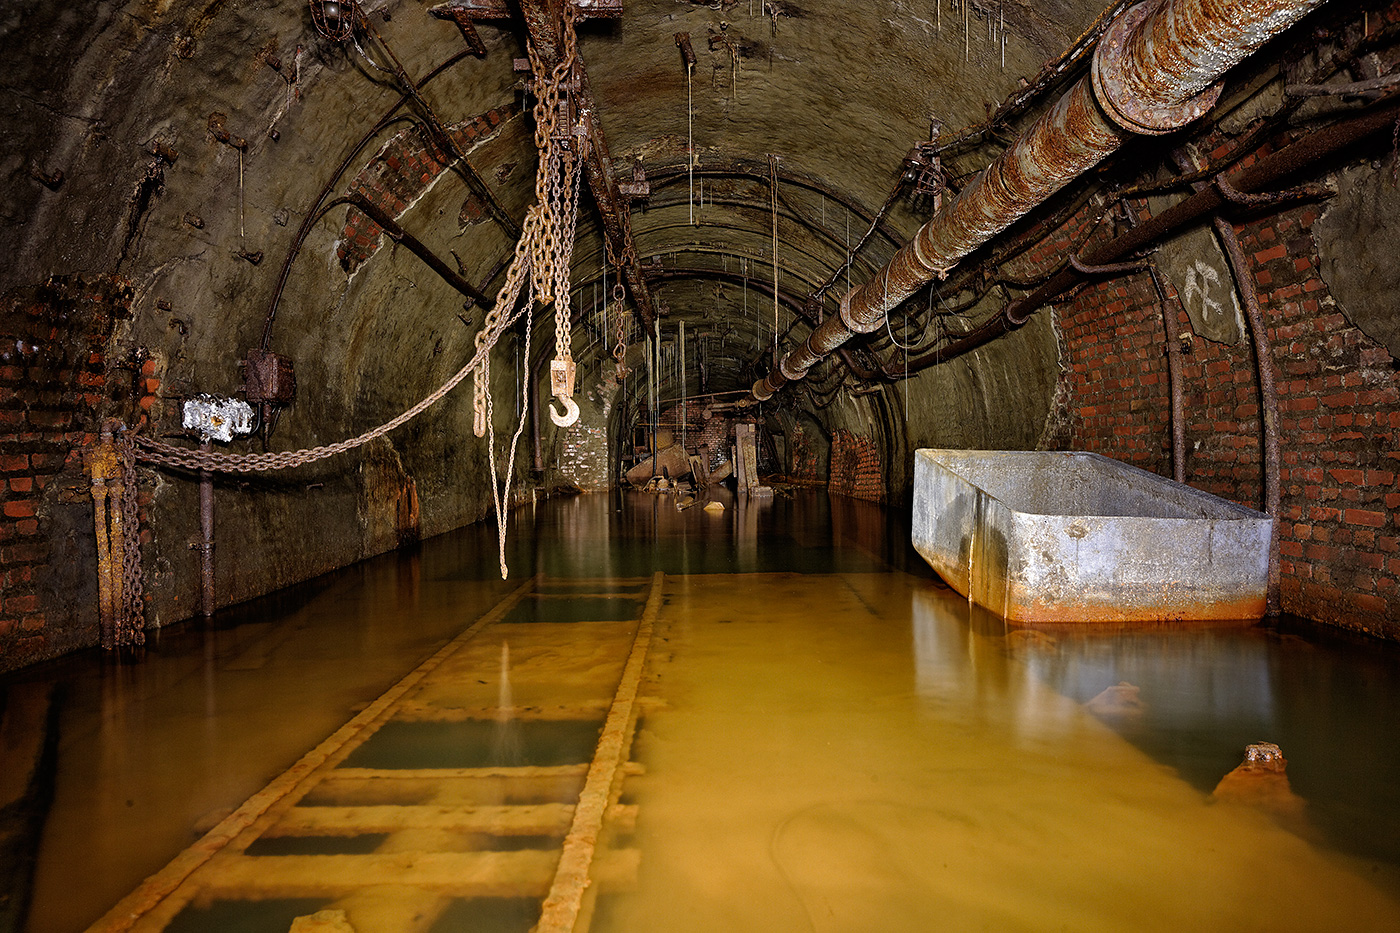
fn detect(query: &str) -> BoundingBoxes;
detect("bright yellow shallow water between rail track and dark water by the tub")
[613,565,1400,932]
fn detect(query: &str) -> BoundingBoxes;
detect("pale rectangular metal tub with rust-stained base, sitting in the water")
[913,450,1273,622]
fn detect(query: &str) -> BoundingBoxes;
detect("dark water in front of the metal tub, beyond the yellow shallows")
[1002,613,1400,864]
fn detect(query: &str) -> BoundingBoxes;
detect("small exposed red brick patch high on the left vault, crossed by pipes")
[336,104,519,272]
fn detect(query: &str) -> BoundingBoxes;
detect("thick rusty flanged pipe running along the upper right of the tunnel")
[753,0,1324,401]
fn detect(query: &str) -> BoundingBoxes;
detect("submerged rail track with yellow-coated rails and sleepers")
[90,573,664,933]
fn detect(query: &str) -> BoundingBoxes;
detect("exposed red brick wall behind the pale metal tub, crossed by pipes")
[1058,194,1400,637]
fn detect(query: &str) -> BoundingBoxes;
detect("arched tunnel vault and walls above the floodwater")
[0,0,1397,667]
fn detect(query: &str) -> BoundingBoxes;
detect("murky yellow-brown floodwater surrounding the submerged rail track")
[8,495,1400,933]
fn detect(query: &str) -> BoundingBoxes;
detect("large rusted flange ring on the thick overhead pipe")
[1092,1,1224,136]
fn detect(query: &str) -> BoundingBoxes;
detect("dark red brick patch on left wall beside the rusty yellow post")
[0,276,160,670]
